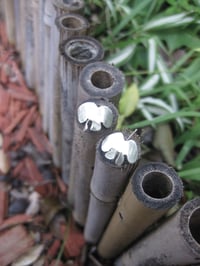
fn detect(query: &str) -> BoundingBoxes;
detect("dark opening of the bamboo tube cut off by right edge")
[189,208,200,244]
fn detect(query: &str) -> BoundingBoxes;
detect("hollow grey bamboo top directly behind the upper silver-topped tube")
[77,62,124,104]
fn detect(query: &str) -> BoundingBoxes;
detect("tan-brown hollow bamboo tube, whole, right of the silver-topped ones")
[97,163,183,259]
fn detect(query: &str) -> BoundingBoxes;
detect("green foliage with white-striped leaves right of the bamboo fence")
[86,0,200,195]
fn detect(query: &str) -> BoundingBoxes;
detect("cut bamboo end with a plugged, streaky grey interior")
[60,36,104,66]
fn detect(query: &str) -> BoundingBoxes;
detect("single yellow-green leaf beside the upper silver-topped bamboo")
[119,83,139,118]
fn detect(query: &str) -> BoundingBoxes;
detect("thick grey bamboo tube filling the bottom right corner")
[115,198,200,266]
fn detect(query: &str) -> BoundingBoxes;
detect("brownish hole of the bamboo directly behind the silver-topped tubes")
[91,70,113,89]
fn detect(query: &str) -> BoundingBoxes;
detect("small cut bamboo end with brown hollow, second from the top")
[55,13,90,37]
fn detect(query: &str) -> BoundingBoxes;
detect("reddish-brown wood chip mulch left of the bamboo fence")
[0,21,84,266]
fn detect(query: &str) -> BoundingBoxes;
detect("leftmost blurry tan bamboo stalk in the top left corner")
[3,0,16,45]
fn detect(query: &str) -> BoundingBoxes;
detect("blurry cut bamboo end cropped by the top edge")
[54,0,84,12]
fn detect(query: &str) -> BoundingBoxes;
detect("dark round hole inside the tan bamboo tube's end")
[142,172,172,199]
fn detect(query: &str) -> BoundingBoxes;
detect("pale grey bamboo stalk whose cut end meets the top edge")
[43,0,84,133]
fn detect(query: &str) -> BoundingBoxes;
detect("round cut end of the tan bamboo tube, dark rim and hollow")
[132,162,183,210]
